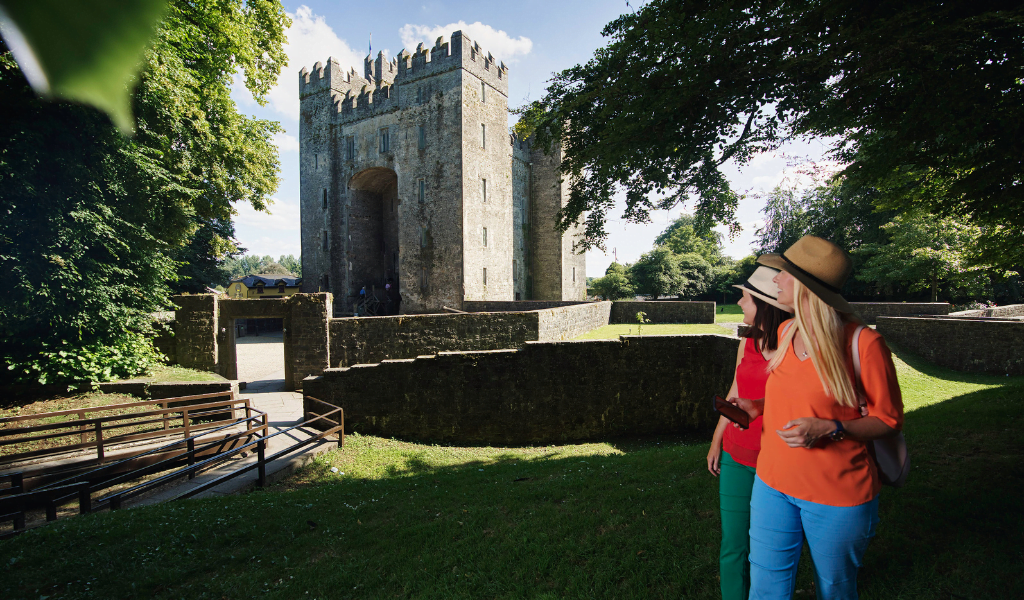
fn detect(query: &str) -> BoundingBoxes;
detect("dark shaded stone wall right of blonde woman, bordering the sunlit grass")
[878,316,1024,375]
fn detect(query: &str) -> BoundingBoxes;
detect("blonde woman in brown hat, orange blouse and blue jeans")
[738,235,903,600]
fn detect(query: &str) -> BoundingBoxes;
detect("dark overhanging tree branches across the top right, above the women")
[516,0,1024,248]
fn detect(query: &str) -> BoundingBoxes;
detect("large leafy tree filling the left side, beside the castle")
[0,0,288,382]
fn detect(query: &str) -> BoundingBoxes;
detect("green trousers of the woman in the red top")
[718,452,754,600]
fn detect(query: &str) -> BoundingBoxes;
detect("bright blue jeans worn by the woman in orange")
[750,477,879,600]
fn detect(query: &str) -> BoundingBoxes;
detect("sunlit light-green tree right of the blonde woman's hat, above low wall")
[856,211,989,302]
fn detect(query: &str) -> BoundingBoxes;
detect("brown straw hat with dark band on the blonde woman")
[758,235,855,312]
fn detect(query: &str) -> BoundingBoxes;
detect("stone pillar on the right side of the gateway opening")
[285,293,332,389]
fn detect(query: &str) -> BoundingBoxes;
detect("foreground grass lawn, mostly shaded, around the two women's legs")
[0,348,1024,600]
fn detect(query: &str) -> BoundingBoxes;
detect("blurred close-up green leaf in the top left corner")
[0,0,167,131]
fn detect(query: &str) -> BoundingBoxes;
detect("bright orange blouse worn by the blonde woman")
[757,324,903,506]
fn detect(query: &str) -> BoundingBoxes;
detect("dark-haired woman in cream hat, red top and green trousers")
[708,266,793,600]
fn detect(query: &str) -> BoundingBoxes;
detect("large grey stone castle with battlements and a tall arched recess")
[299,32,587,312]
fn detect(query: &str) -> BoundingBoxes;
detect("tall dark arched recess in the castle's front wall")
[347,167,399,301]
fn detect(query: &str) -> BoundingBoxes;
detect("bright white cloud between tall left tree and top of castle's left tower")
[258,5,364,119]
